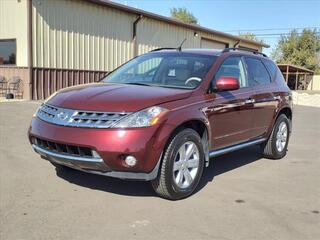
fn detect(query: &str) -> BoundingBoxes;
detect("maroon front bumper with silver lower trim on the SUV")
[29,117,167,181]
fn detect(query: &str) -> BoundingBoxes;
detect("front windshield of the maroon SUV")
[102,52,217,89]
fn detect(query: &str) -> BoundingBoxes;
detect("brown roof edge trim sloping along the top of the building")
[87,0,270,48]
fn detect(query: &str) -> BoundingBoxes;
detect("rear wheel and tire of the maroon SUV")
[262,114,291,159]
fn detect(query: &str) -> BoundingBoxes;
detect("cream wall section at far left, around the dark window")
[0,0,28,67]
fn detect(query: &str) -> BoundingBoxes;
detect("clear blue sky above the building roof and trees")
[114,0,320,54]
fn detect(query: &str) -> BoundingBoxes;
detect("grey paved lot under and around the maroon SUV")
[0,101,320,240]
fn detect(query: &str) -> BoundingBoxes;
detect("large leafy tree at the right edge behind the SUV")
[271,29,320,73]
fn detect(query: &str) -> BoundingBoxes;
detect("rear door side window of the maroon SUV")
[245,57,271,86]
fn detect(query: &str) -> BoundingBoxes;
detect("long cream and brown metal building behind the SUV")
[0,0,269,99]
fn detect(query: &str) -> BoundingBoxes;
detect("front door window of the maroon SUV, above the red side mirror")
[214,57,248,88]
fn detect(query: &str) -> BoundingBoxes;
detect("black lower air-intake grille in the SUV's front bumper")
[32,137,96,158]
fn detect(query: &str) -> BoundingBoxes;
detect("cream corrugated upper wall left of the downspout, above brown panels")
[32,0,135,71]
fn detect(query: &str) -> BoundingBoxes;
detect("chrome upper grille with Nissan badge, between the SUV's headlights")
[37,104,129,128]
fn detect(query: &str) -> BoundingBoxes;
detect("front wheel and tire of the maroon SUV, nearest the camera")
[151,128,204,200]
